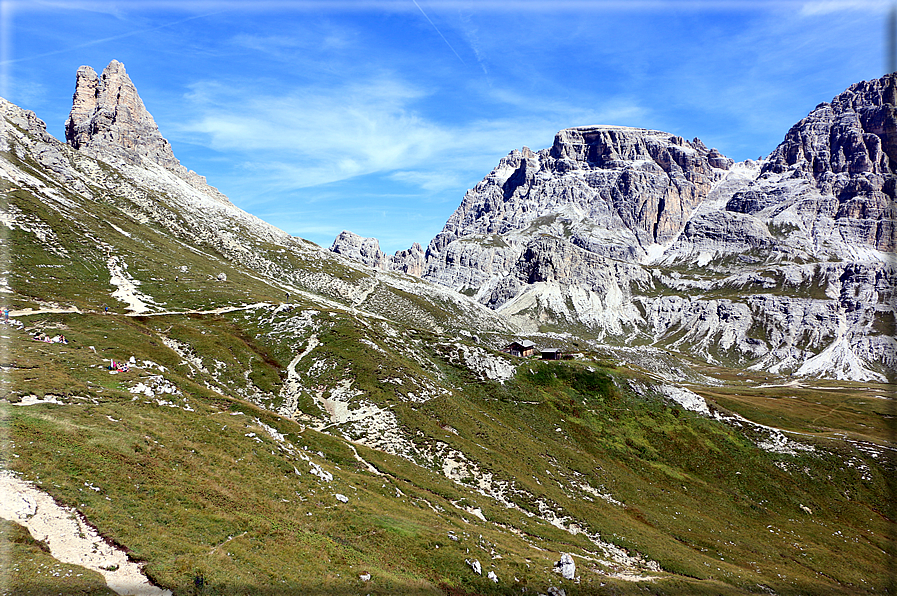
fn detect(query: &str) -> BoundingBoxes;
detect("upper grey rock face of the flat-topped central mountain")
[427,126,731,261]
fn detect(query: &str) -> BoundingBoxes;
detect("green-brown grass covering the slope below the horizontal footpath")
[2,310,893,594]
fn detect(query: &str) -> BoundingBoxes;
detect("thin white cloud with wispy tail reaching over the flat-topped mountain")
[178,77,642,196]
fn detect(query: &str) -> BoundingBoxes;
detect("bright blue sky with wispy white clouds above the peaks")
[0,0,892,252]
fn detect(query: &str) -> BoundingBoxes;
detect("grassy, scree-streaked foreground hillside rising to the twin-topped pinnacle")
[0,62,897,596]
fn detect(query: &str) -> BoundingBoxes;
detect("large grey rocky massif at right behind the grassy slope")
[331,74,897,380]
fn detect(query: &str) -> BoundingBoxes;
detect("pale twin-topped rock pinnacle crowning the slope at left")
[65,60,227,201]
